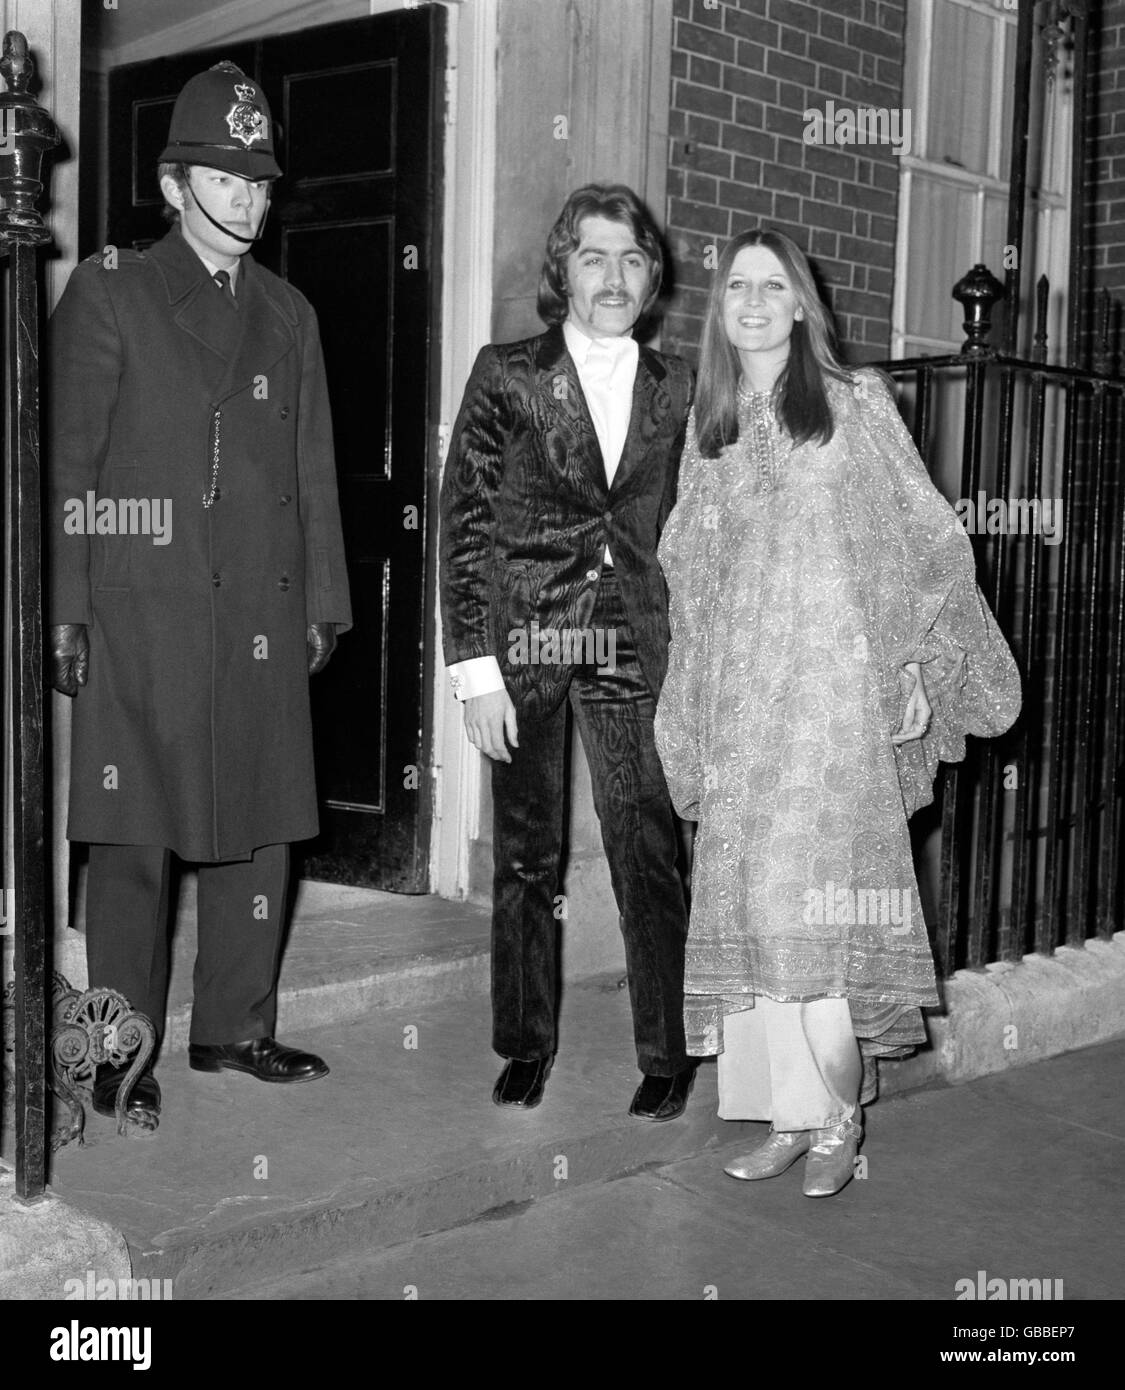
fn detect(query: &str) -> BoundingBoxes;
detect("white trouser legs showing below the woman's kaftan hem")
[719,994,864,1130]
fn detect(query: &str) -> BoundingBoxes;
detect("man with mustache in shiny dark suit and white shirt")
[441,185,694,1120]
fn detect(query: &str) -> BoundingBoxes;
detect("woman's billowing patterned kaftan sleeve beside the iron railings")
[837,371,1021,816]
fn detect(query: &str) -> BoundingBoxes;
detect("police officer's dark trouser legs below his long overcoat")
[86,845,289,1044]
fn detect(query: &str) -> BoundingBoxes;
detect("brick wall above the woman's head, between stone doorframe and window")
[663,0,905,361]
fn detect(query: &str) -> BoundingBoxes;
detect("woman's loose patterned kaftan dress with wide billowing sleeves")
[656,371,1021,1056]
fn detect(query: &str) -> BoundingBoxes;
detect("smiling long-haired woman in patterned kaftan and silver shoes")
[656,232,1019,1197]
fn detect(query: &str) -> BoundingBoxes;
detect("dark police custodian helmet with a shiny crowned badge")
[160,61,281,179]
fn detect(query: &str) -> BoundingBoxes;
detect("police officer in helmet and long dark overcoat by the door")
[47,63,350,1131]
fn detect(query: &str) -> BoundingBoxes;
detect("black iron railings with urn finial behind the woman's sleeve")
[882,265,1125,976]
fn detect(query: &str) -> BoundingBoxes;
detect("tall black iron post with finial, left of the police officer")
[0,31,58,1202]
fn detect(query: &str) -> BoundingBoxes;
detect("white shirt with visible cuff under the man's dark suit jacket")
[448,320,640,701]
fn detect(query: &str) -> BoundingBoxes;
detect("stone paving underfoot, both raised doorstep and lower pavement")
[43,979,1125,1300]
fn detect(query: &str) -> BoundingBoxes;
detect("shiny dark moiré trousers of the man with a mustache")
[492,571,687,1076]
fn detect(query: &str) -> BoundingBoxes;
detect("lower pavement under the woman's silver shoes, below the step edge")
[232,1040,1125,1301]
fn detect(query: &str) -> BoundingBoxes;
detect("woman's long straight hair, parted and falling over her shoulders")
[695,229,851,459]
